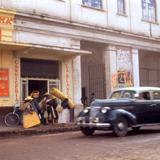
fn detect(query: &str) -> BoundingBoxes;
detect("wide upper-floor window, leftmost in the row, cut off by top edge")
[82,0,102,9]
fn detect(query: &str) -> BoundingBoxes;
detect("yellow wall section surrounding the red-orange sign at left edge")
[0,50,14,107]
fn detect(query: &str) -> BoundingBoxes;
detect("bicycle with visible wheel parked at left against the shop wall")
[4,104,20,127]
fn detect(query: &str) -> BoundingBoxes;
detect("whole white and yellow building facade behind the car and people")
[0,0,160,120]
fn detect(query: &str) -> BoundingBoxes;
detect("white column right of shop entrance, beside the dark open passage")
[73,56,83,117]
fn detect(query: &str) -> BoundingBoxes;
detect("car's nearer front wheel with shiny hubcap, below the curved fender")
[112,117,128,137]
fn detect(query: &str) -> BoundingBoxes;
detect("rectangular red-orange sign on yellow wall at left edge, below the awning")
[0,69,9,97]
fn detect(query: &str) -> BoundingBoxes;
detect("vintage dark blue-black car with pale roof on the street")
[77,87,160,137]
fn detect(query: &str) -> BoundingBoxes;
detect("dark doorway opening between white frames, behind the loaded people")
[28,80,47,99]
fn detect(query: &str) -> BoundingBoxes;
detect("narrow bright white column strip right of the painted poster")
[132,48,140,87]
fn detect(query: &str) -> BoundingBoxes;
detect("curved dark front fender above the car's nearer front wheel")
[109,109,137,125]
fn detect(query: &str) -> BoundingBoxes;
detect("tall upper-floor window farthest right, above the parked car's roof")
[142,0,156,22]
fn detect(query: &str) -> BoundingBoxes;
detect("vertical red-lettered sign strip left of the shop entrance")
[14,59,20,102]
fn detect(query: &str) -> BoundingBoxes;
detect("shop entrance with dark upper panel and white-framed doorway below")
[21,58,60,101]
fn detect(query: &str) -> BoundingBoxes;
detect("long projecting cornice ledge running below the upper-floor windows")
[16,12,160,42]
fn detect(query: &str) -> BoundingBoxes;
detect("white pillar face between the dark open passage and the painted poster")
[103,45,116,98]
